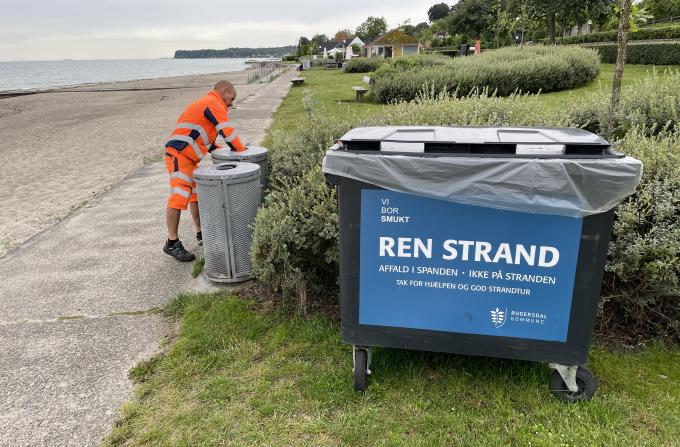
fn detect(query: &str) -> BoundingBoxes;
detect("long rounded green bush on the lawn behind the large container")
[372,46,600,102]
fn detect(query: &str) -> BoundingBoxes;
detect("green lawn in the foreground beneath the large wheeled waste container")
[105,295,680,446]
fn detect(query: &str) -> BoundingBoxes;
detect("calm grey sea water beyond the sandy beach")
[0,59,256,91]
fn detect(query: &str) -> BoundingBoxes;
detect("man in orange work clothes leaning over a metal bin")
[163,81,245,262]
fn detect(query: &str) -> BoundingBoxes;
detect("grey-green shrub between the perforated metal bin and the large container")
[251,165,339,313]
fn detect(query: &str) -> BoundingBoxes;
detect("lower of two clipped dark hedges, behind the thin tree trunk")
[583,41,680,65]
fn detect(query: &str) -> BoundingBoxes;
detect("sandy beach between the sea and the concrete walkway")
[0,67,276,257]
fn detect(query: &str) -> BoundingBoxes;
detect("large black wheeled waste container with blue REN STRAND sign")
[323,127,642,401]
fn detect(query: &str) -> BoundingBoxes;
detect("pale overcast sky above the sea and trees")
[0,0,437,61]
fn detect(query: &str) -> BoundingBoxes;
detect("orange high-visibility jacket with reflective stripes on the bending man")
[166,90,245,163]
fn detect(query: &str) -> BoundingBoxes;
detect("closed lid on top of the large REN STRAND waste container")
[339,126,623,158]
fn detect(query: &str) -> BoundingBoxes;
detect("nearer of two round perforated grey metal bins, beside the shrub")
[194,162,262,282]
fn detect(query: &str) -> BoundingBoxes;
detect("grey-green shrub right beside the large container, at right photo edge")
[600,129,680,341]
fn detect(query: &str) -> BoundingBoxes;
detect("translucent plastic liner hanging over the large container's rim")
[323,149,642,217]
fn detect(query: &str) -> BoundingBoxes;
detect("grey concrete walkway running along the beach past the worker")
[0,66,295,446]
